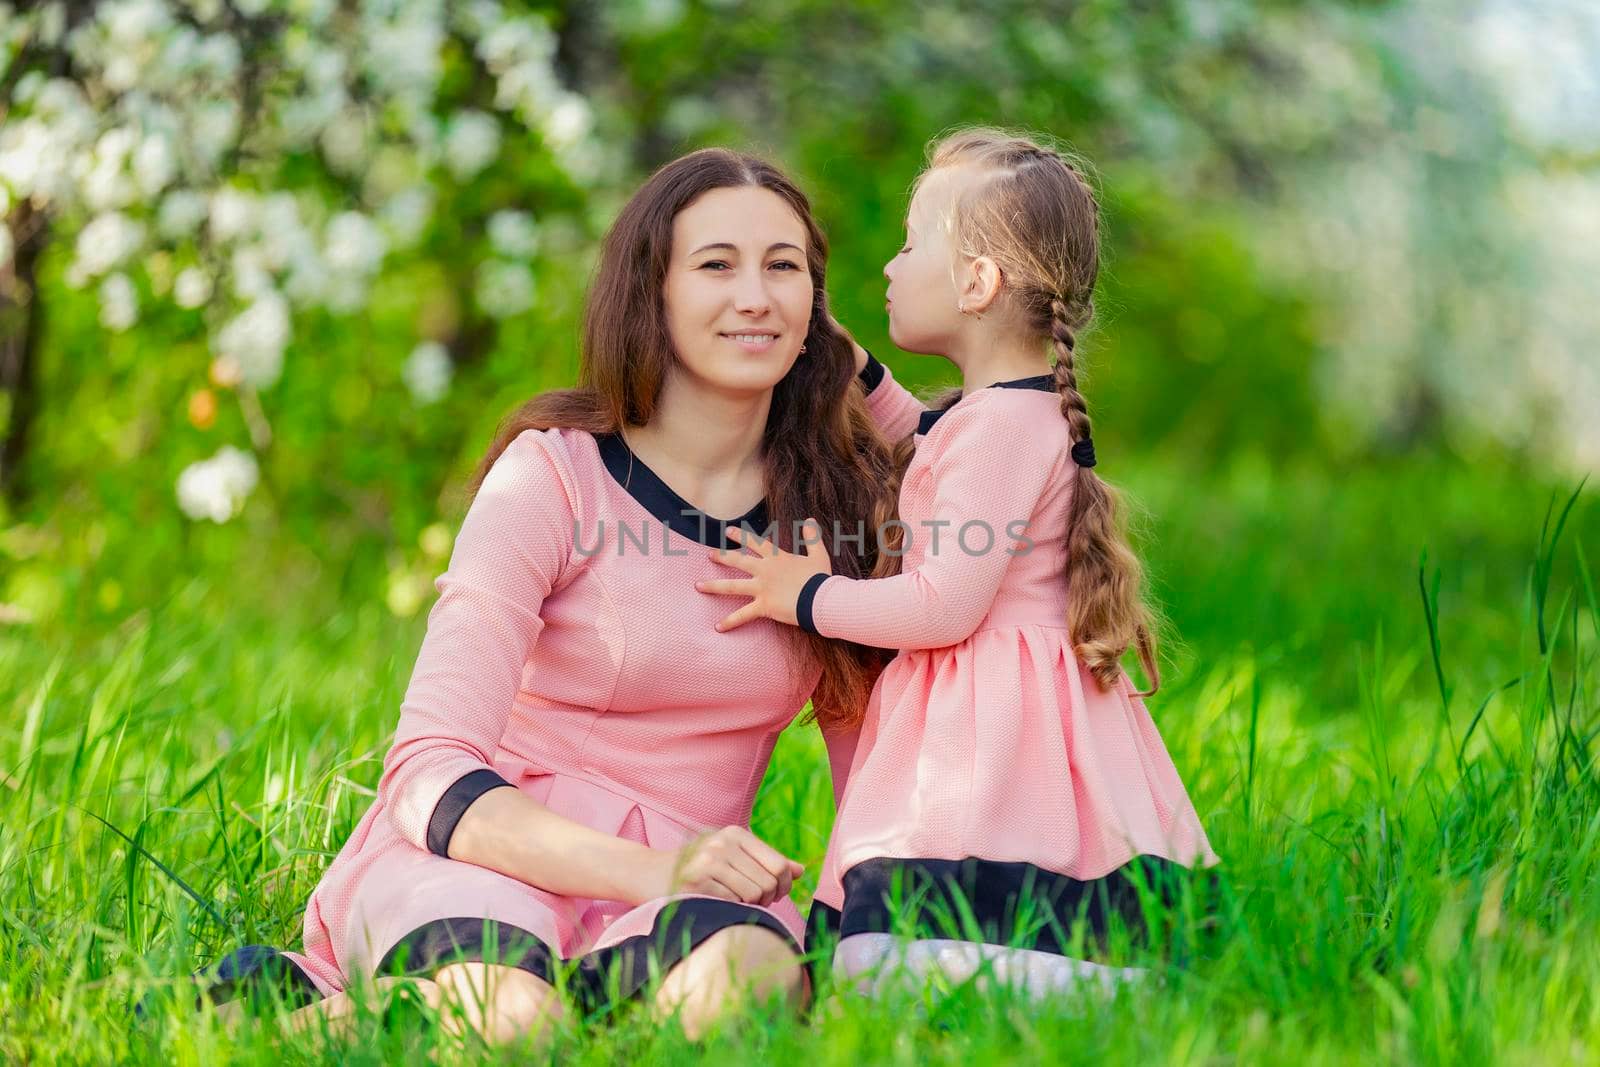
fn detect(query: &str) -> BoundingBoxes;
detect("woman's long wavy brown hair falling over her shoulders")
[470,149,898,728]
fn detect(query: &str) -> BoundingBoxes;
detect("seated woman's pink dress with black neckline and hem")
[204,429,821,995]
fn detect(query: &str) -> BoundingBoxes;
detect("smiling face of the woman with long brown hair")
[666,186,813,392]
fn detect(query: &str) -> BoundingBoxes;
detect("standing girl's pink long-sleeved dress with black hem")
[797,360,1216,952]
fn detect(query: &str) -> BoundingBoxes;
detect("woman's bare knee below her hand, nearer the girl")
[654,926,806,1038]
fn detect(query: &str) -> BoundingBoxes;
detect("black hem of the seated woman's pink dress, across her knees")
[378,899,802,1014]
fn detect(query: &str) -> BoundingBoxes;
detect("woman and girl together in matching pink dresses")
[187,130,1216,1041]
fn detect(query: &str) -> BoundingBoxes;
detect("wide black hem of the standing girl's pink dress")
[838,856,1213,960]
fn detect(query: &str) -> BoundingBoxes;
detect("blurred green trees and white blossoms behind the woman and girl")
[0,0,1600,689]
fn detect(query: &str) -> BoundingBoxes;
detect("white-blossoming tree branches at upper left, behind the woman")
[0,0,602,522]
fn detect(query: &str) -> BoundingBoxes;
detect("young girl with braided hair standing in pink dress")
[696,130,1216,992]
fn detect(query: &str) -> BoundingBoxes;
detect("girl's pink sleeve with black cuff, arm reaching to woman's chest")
[795,394,1064,649]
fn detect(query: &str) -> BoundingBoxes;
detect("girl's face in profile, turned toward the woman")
[883,170,965,355]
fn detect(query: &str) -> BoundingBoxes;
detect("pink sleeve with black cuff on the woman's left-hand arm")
[378,430,578,856]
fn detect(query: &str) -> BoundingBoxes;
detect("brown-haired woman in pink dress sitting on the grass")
[200,149,893,1040]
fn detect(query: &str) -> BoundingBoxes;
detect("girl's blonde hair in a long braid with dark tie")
[917,128,1160,696]
